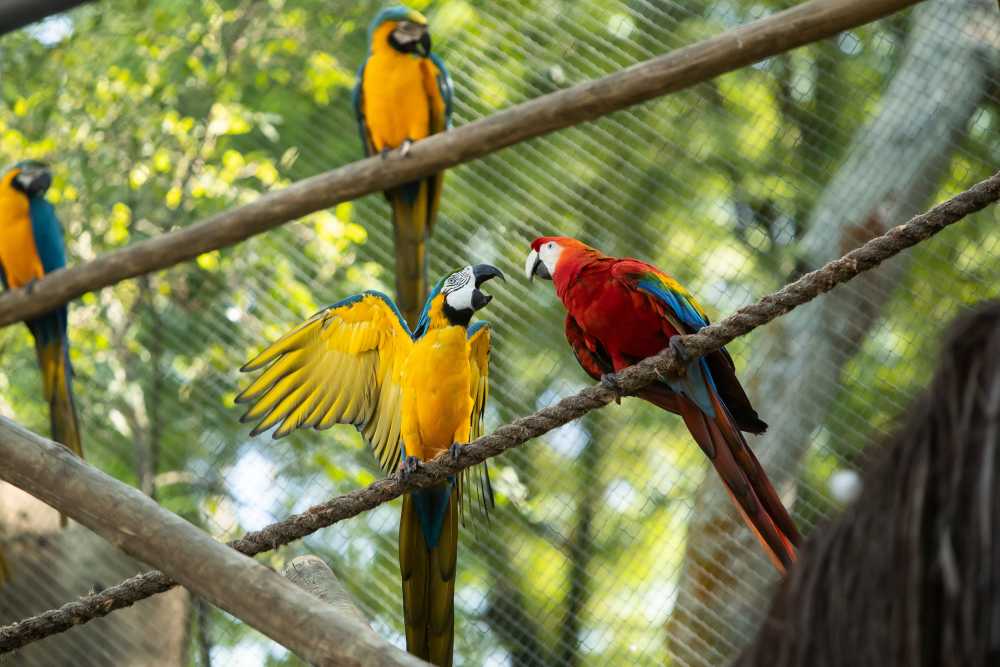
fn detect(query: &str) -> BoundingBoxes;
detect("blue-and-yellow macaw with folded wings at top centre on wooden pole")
[354,7,452,326]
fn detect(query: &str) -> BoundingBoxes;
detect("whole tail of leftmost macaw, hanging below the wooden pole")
[28,306,83,525]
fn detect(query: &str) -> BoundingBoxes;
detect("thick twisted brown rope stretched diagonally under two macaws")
[0,172,1000,653]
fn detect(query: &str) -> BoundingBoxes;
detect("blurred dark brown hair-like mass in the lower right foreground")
[736,301,1000,667]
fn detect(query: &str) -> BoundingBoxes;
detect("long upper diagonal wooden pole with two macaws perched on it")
[0,0,919,326]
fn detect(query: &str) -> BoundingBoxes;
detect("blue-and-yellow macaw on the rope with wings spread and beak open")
[236,264,503,665]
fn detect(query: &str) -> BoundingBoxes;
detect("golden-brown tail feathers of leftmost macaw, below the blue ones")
[32,329,83,528]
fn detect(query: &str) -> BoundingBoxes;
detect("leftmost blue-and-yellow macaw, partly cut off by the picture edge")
[0,161,83,536]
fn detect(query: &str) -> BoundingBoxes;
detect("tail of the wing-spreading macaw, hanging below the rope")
[399,481,459,667]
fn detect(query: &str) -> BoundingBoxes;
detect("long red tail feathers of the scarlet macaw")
[639,387,801,573]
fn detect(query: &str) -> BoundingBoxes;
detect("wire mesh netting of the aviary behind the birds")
[0,0,1000,666]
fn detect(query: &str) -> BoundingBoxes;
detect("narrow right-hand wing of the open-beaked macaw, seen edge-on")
[458,321,494,518]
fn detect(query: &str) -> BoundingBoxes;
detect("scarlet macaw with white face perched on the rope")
[525,236,800,572]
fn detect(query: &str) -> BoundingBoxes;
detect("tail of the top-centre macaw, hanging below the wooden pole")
[386,174,444,329]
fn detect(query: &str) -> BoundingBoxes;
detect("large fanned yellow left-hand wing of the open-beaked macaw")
[236,291,413,472]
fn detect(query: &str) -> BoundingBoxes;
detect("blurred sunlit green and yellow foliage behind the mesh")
[0,0,1000,665]
